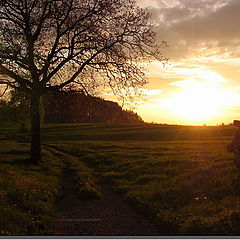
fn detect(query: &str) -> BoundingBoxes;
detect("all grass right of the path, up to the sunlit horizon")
[41,125,240,235]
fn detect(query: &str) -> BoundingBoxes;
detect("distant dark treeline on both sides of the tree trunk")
[0,90,143,125]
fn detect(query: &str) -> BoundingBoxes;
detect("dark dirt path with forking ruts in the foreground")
[55,171,160,236]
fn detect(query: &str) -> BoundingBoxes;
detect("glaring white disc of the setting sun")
[164,75,234,122]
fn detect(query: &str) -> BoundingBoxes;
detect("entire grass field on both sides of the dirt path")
[0,124,240,235]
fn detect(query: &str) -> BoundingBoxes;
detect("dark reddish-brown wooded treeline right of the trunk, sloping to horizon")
[43,91,143,123]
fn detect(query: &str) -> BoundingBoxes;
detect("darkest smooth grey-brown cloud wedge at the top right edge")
[170,0,240,41]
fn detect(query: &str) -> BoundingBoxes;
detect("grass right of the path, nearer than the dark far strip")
[53,141,240,235]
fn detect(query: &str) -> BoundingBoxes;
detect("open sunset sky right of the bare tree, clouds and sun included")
[108,0,240,125]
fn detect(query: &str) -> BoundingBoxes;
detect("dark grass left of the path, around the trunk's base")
[0,135,62,236]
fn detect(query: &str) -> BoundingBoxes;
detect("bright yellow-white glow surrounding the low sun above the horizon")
[124,66,240,125]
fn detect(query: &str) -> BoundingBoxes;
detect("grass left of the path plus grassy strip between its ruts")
[0,129,101,236]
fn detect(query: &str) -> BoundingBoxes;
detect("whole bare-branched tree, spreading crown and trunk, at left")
[0,0,165,163]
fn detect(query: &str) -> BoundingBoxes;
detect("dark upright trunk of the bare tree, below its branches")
[30,94,41,164]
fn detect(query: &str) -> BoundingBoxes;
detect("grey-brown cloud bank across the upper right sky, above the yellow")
[148,0,240,58]
